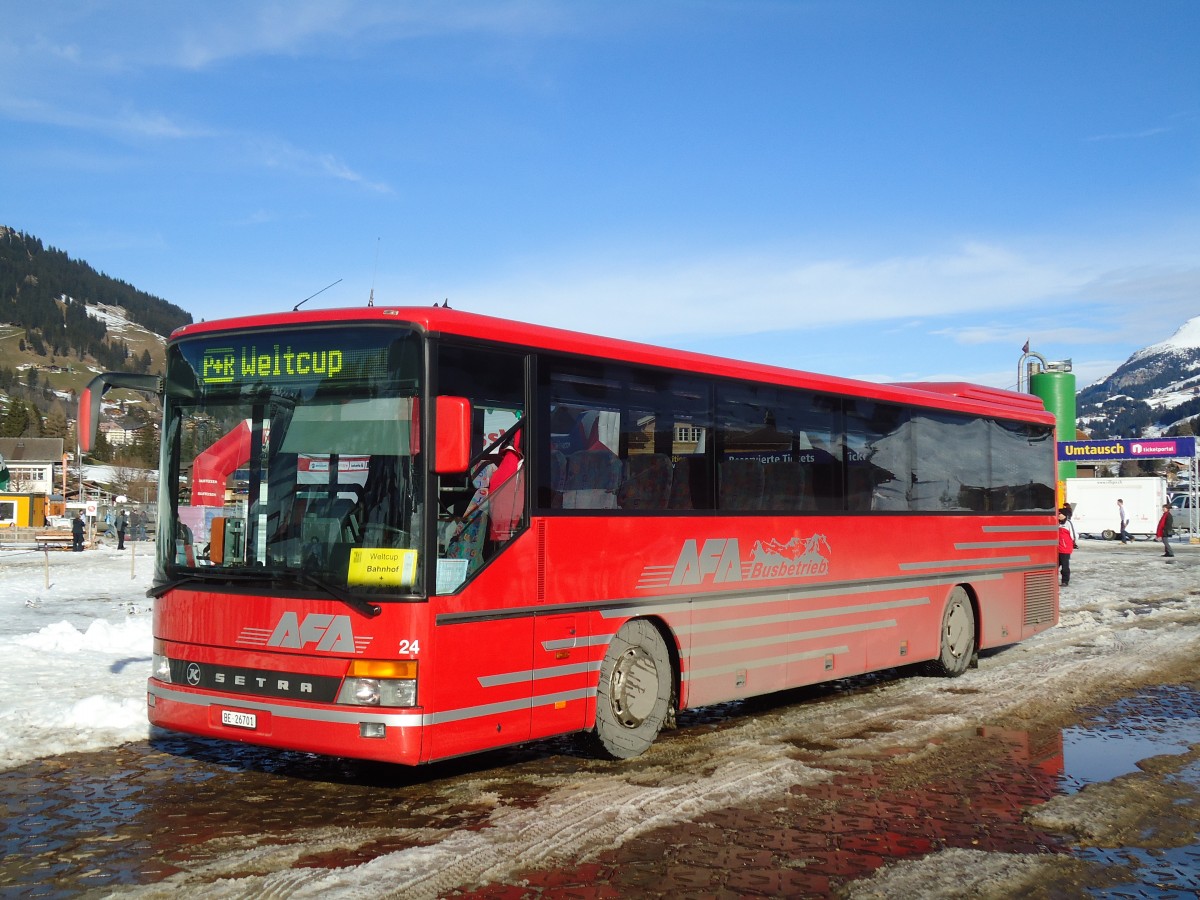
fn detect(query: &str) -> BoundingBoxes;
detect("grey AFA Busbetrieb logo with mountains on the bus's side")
[662,534,832,587]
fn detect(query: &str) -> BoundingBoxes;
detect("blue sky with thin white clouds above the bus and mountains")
[0,0,1200,386]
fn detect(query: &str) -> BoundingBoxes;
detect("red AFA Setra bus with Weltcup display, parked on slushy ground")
[80,307,1058,764]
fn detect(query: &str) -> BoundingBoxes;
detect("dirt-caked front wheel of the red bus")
[589,619,674,760]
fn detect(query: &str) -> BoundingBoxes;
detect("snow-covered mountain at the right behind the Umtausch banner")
[1076,316,1200,438]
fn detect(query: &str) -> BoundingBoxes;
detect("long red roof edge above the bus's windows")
[170,305,1055,425]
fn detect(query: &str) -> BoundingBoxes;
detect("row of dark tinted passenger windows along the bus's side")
[538,359,1054,514]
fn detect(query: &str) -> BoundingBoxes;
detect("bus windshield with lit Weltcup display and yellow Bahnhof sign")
[157,328,424,596]
